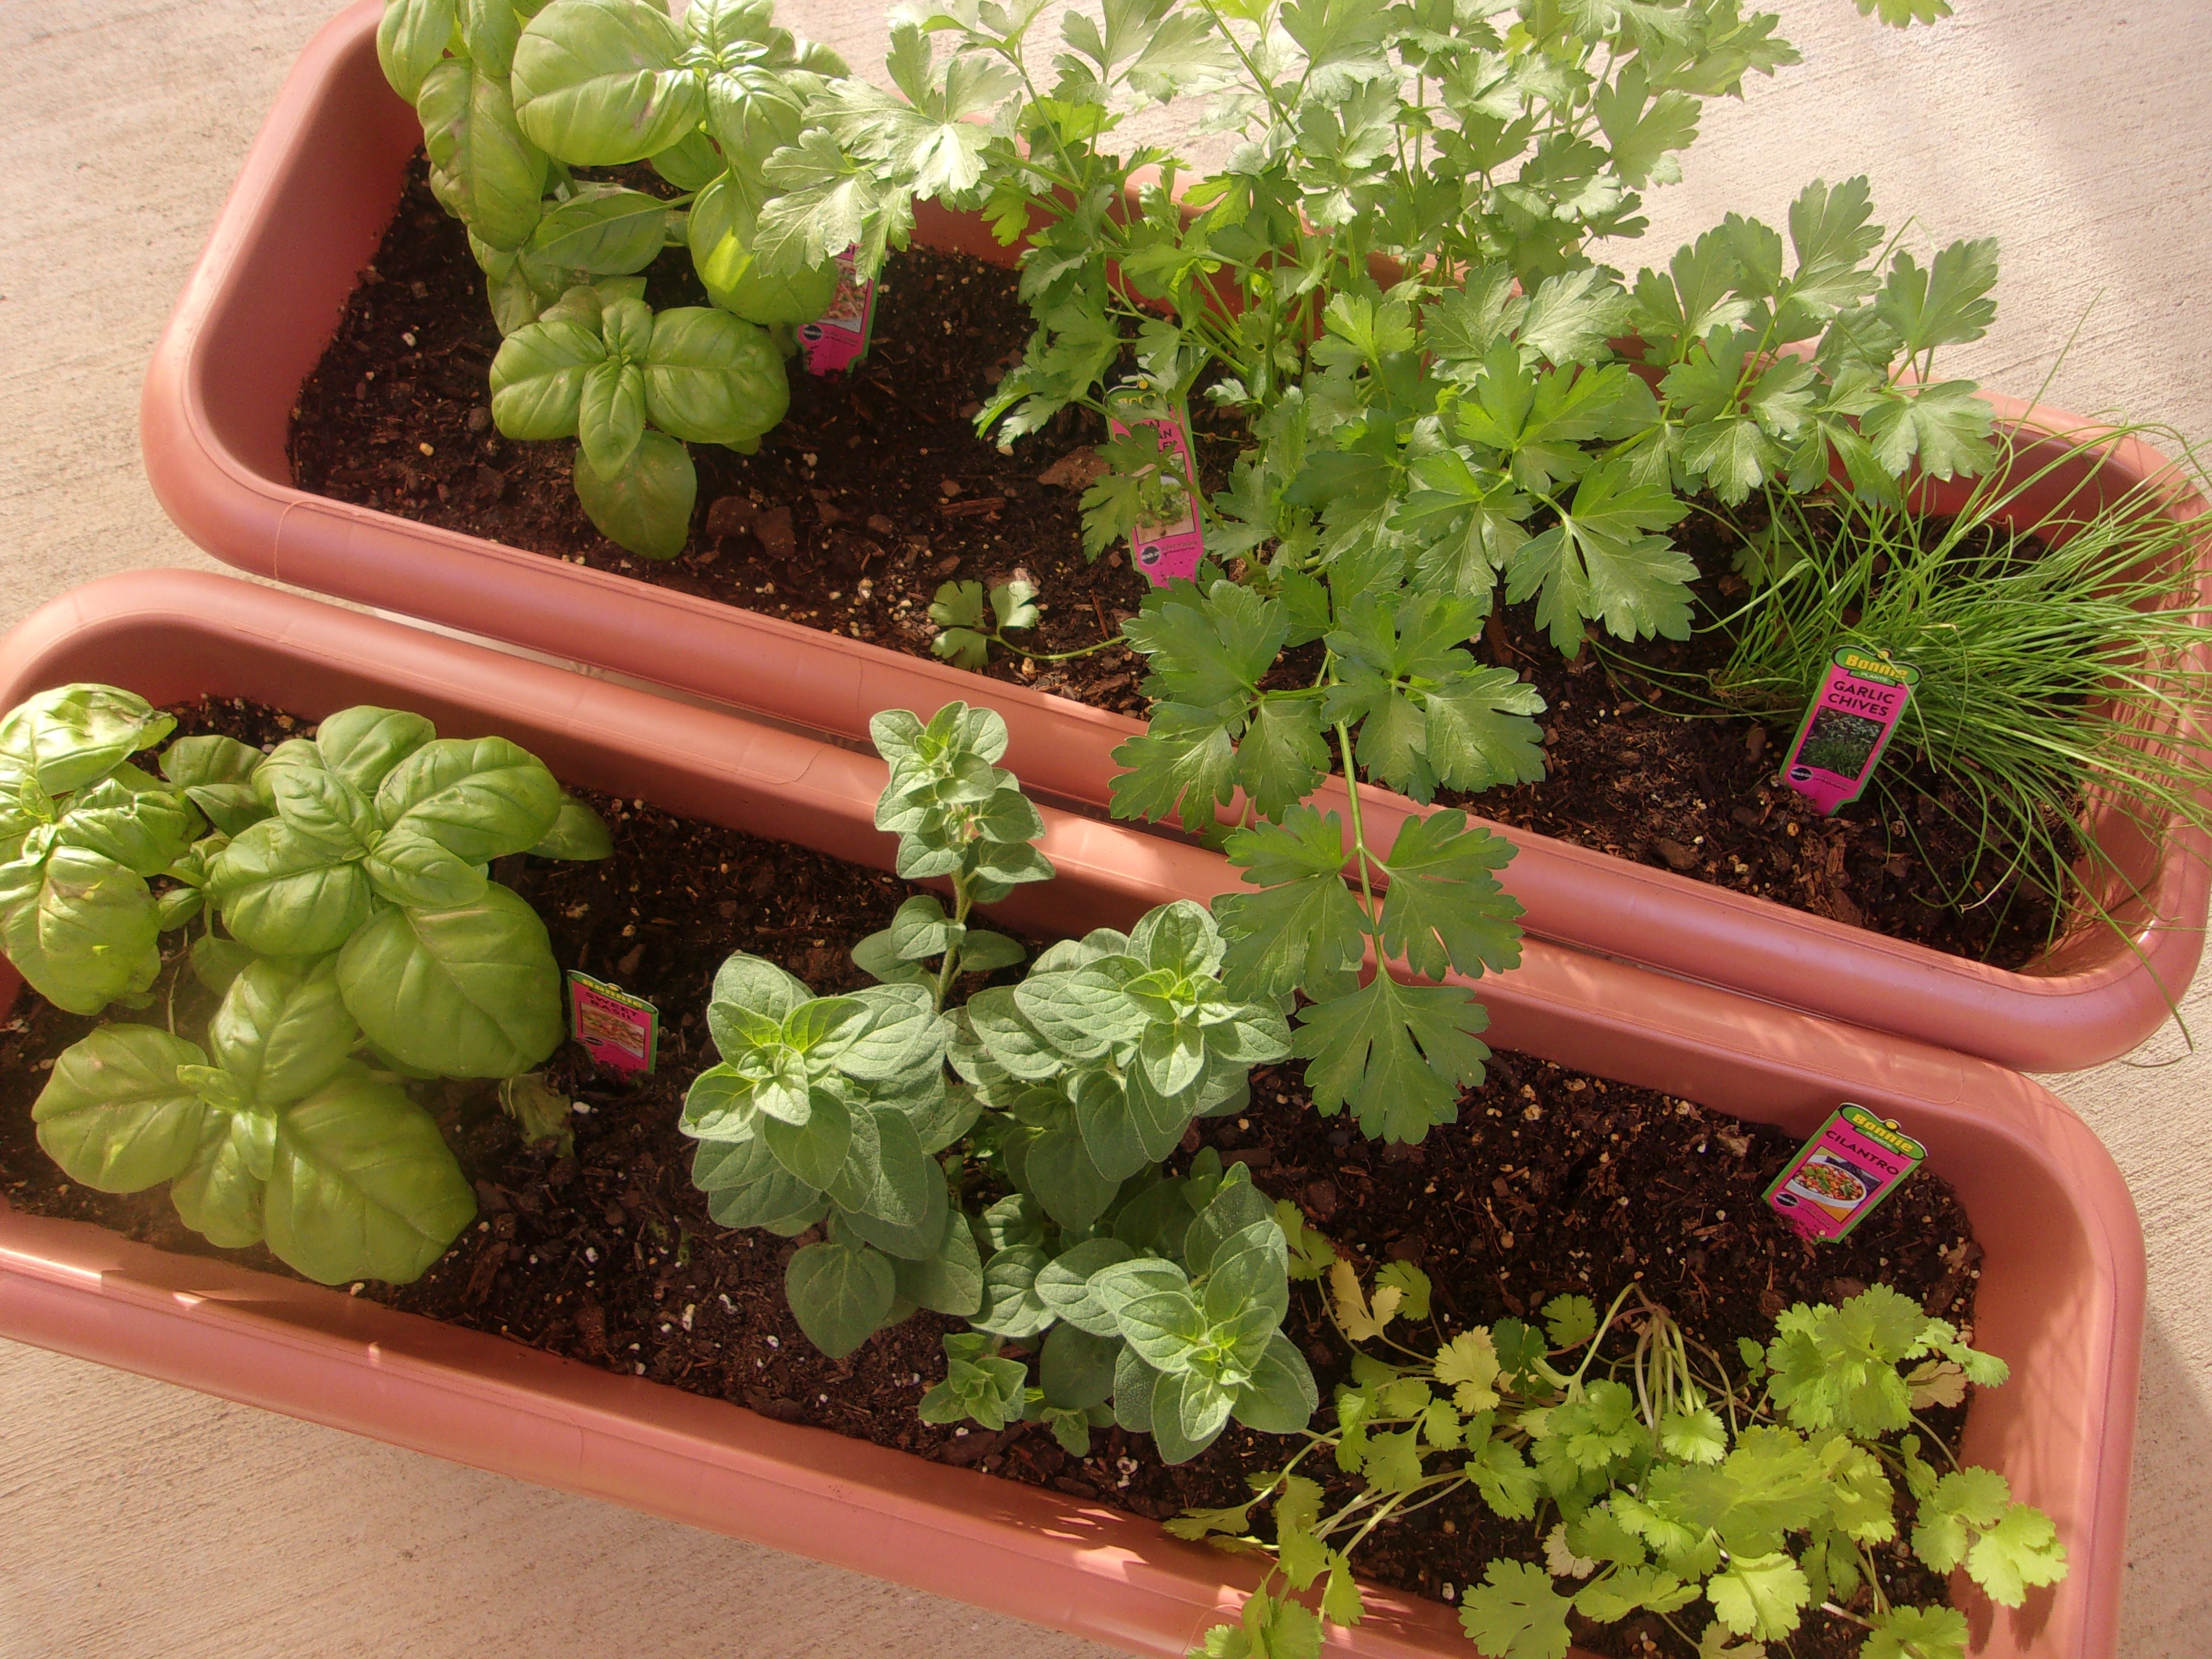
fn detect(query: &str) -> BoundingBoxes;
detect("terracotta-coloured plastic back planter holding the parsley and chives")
[142,0,2212,1070]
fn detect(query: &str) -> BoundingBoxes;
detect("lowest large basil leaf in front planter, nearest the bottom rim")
[263,1070,478,1285]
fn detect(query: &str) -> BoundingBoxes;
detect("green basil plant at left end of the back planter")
[376,0,845,560]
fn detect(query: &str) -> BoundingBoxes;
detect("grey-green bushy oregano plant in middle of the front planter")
[681,703,1318,1460]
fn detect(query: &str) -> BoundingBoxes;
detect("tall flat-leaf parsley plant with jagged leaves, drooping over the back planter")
[739,0,1995,1139]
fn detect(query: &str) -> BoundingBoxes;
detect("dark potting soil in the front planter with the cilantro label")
[0,701,1982,1659]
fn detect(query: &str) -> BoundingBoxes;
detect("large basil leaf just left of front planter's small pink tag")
[338,883,562,1077]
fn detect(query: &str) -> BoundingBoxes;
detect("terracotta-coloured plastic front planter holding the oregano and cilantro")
[0,571,2143,1659]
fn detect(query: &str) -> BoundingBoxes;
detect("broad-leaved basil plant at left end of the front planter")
[0,685,613,1283]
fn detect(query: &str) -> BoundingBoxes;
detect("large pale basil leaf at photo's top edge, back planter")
[513,0,706,168]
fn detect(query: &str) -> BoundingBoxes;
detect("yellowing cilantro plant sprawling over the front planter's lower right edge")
[1168,1248,2066,1659]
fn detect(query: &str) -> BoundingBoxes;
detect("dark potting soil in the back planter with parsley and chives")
[290,155,2051,967]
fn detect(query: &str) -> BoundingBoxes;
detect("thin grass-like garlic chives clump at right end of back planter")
[1654,433,2212,955]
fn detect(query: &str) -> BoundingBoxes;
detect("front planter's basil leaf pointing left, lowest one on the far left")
[31,1024,208,1192]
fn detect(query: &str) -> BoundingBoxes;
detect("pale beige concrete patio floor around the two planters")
[0,0,2212,1659]
